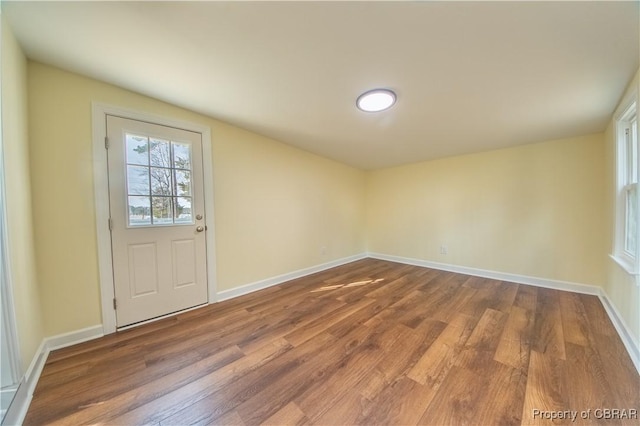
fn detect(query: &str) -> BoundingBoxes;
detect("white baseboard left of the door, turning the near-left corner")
[2,325,104,425]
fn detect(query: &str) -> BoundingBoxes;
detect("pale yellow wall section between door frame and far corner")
[213,126,365,290]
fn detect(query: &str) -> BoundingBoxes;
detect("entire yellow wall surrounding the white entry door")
[29,62,365,335]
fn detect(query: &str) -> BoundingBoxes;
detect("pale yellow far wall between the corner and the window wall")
[367,134,604,286]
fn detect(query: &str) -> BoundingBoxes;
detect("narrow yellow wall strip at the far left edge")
[0,14,44,372]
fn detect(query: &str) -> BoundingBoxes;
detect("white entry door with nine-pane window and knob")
[107,116,208,327]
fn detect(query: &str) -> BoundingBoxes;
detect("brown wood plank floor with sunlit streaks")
[25,259,640,425]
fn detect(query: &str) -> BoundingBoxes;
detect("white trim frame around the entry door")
[91,102,217,334]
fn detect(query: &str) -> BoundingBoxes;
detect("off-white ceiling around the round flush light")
[2,1,640,169]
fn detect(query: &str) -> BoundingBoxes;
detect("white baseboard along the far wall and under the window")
[368,253,640,374]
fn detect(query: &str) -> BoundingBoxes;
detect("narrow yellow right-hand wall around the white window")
[602,71,640,349]
